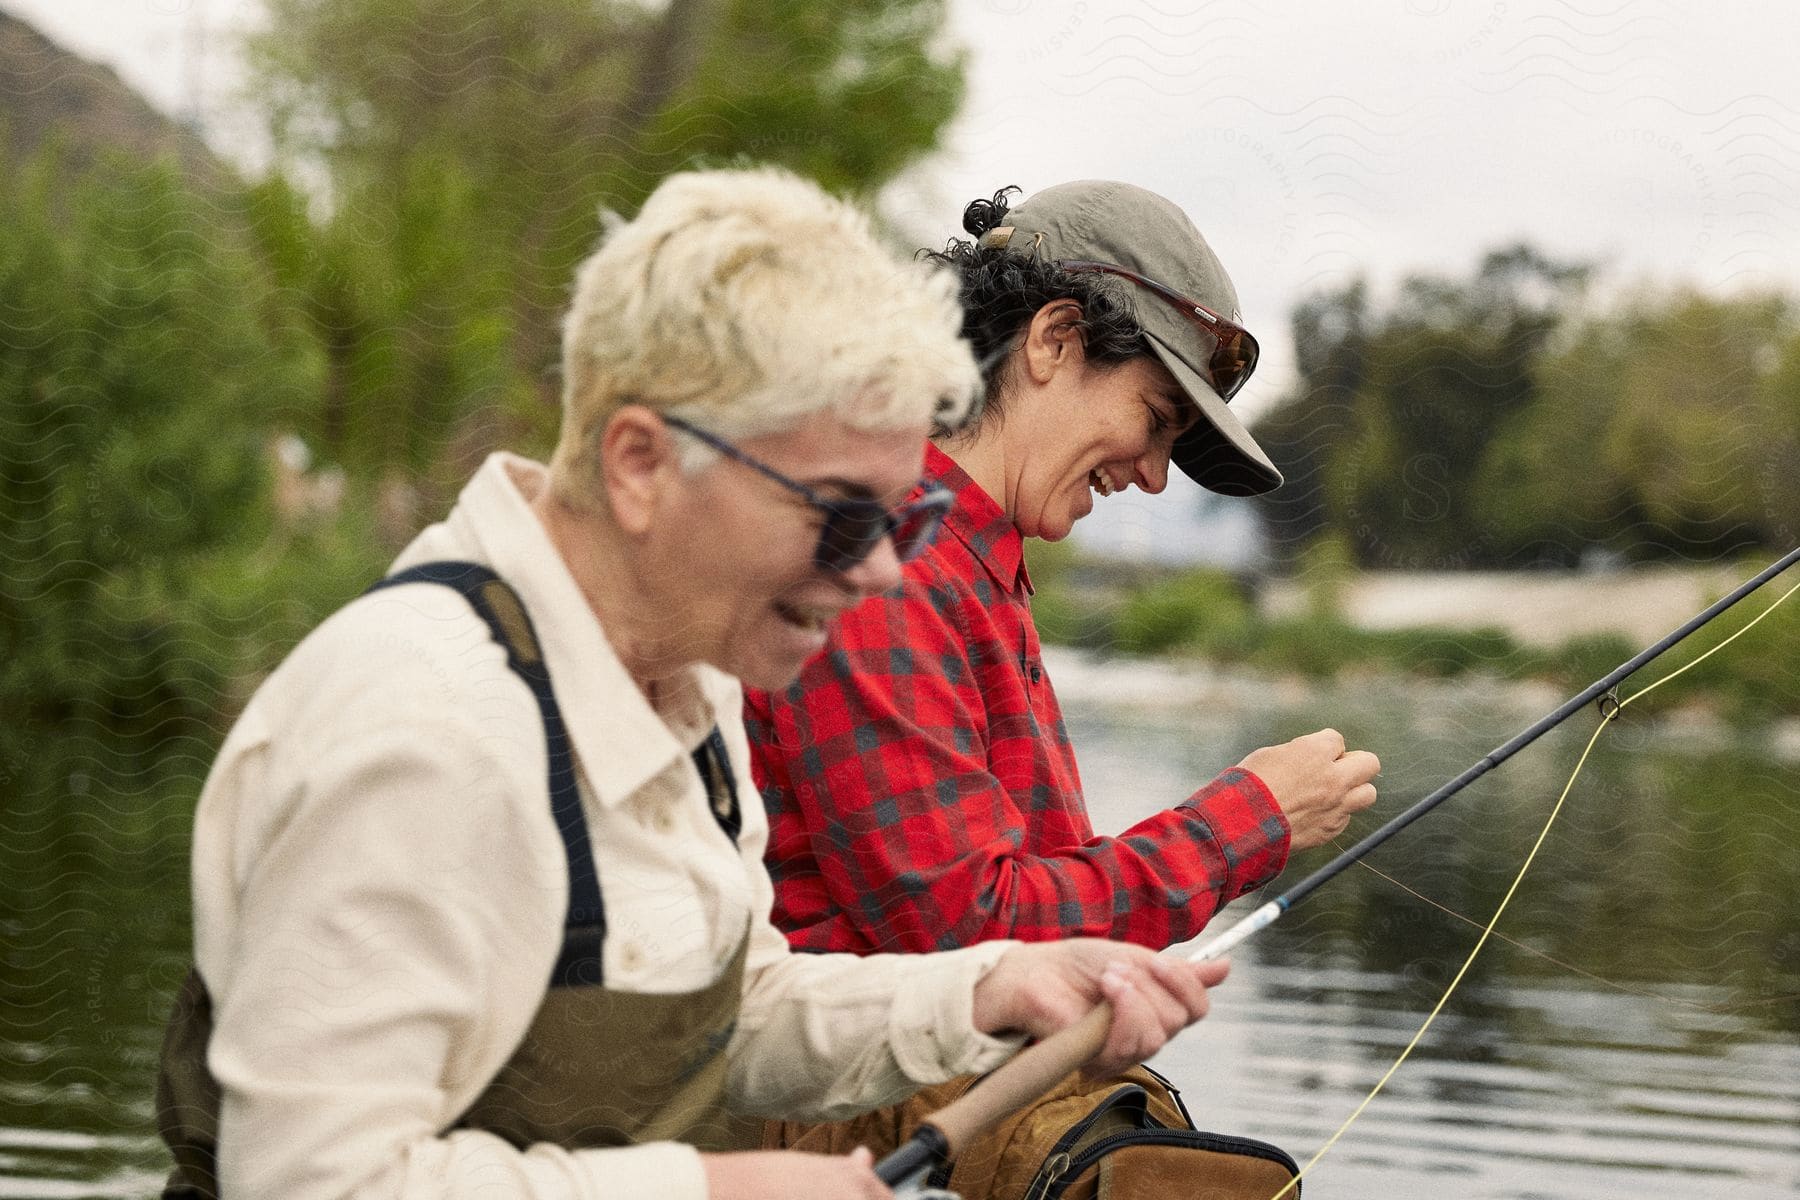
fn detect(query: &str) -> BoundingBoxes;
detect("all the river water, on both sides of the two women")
[0,655,1800,1200]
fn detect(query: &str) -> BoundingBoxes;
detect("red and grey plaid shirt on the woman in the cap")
[745,446,1287,954]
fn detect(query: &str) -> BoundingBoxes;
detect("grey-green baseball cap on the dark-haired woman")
[981,180,1282,497]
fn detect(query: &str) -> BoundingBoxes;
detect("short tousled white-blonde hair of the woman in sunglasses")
[551,167,981,509]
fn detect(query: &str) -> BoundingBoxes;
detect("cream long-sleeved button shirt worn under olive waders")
[194,455,1015,1200]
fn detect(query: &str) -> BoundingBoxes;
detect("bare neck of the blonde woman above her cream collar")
[531,488,693,703]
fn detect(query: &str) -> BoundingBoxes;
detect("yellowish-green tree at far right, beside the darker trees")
[1474,293,1800,561]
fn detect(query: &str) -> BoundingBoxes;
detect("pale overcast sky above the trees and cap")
[0,0,1800,557]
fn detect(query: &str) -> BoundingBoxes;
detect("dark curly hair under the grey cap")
[920,187,1148,437]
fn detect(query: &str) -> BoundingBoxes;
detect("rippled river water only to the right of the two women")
[1053,658,1800,1200]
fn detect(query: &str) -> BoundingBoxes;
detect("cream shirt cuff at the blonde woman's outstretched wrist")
[887,941,1024,1087]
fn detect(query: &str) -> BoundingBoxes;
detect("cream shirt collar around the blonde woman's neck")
[394,452,742,806]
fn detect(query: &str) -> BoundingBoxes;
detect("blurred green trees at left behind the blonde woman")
[0,0,961,777]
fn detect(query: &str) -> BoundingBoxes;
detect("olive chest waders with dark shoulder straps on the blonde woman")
[157,563,760,1200]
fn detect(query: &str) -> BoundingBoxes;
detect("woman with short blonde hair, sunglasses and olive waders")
[157,171,1222,1200]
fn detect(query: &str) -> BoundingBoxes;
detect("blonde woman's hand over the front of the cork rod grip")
[974,937,1231,1076]
